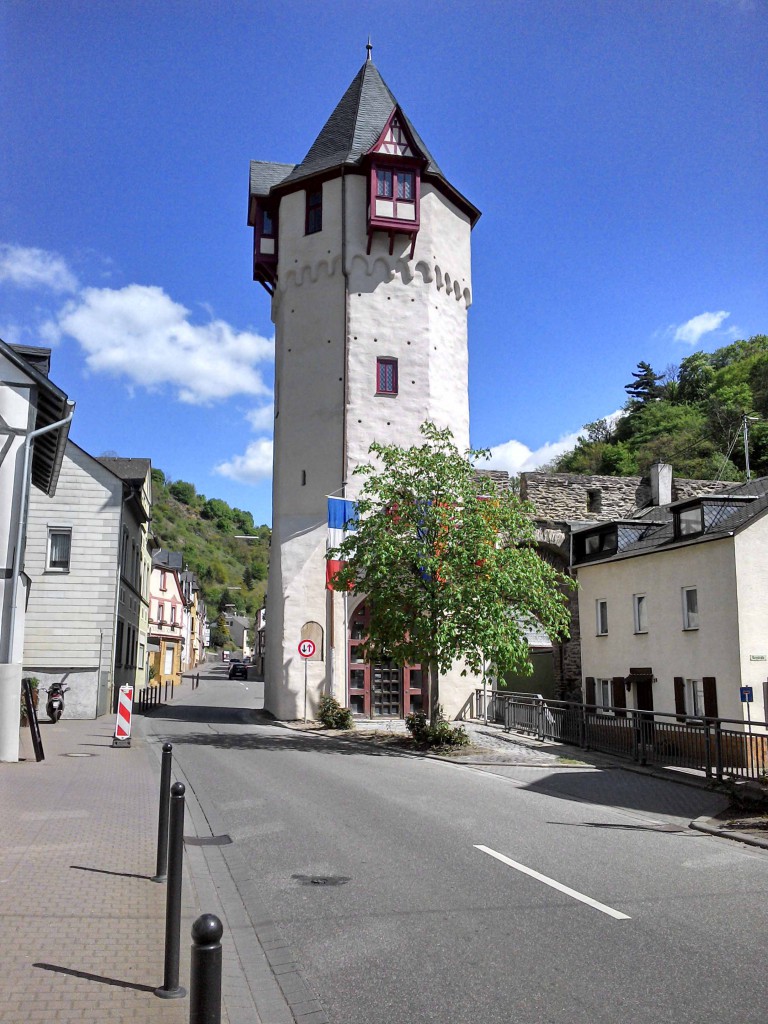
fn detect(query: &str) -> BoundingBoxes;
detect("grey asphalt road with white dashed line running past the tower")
[153,667,768,1024]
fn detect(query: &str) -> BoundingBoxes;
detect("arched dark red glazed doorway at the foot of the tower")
[347,600,426,718]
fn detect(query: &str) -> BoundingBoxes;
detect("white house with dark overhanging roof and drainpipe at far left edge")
[0,341,75,761]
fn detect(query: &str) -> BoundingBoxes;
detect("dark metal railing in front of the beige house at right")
[462,689,768,779]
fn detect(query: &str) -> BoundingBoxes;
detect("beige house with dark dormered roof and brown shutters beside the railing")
[572,478,768,722]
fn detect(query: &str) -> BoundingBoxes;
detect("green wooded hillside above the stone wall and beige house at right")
[548,334,768,480]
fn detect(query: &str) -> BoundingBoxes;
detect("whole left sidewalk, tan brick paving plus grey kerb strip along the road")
[0,700,307,1024]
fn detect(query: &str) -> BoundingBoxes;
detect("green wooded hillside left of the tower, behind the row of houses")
[152,469,270,620]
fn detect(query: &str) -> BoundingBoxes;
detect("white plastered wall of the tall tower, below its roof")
[265,175,473,719]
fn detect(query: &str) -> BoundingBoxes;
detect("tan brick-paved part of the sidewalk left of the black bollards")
[0,716,199,1024]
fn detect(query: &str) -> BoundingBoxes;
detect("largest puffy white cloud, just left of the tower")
[58,285,273,404]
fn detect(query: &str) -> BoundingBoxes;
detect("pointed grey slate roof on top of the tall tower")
[251,57,480,224]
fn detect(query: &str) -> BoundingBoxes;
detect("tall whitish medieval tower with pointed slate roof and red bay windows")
[249,48,479,719]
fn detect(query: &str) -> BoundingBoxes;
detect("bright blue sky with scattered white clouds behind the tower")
[0,0,768,522]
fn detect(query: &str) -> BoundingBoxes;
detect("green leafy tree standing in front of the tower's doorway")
[329,423,571,721]
